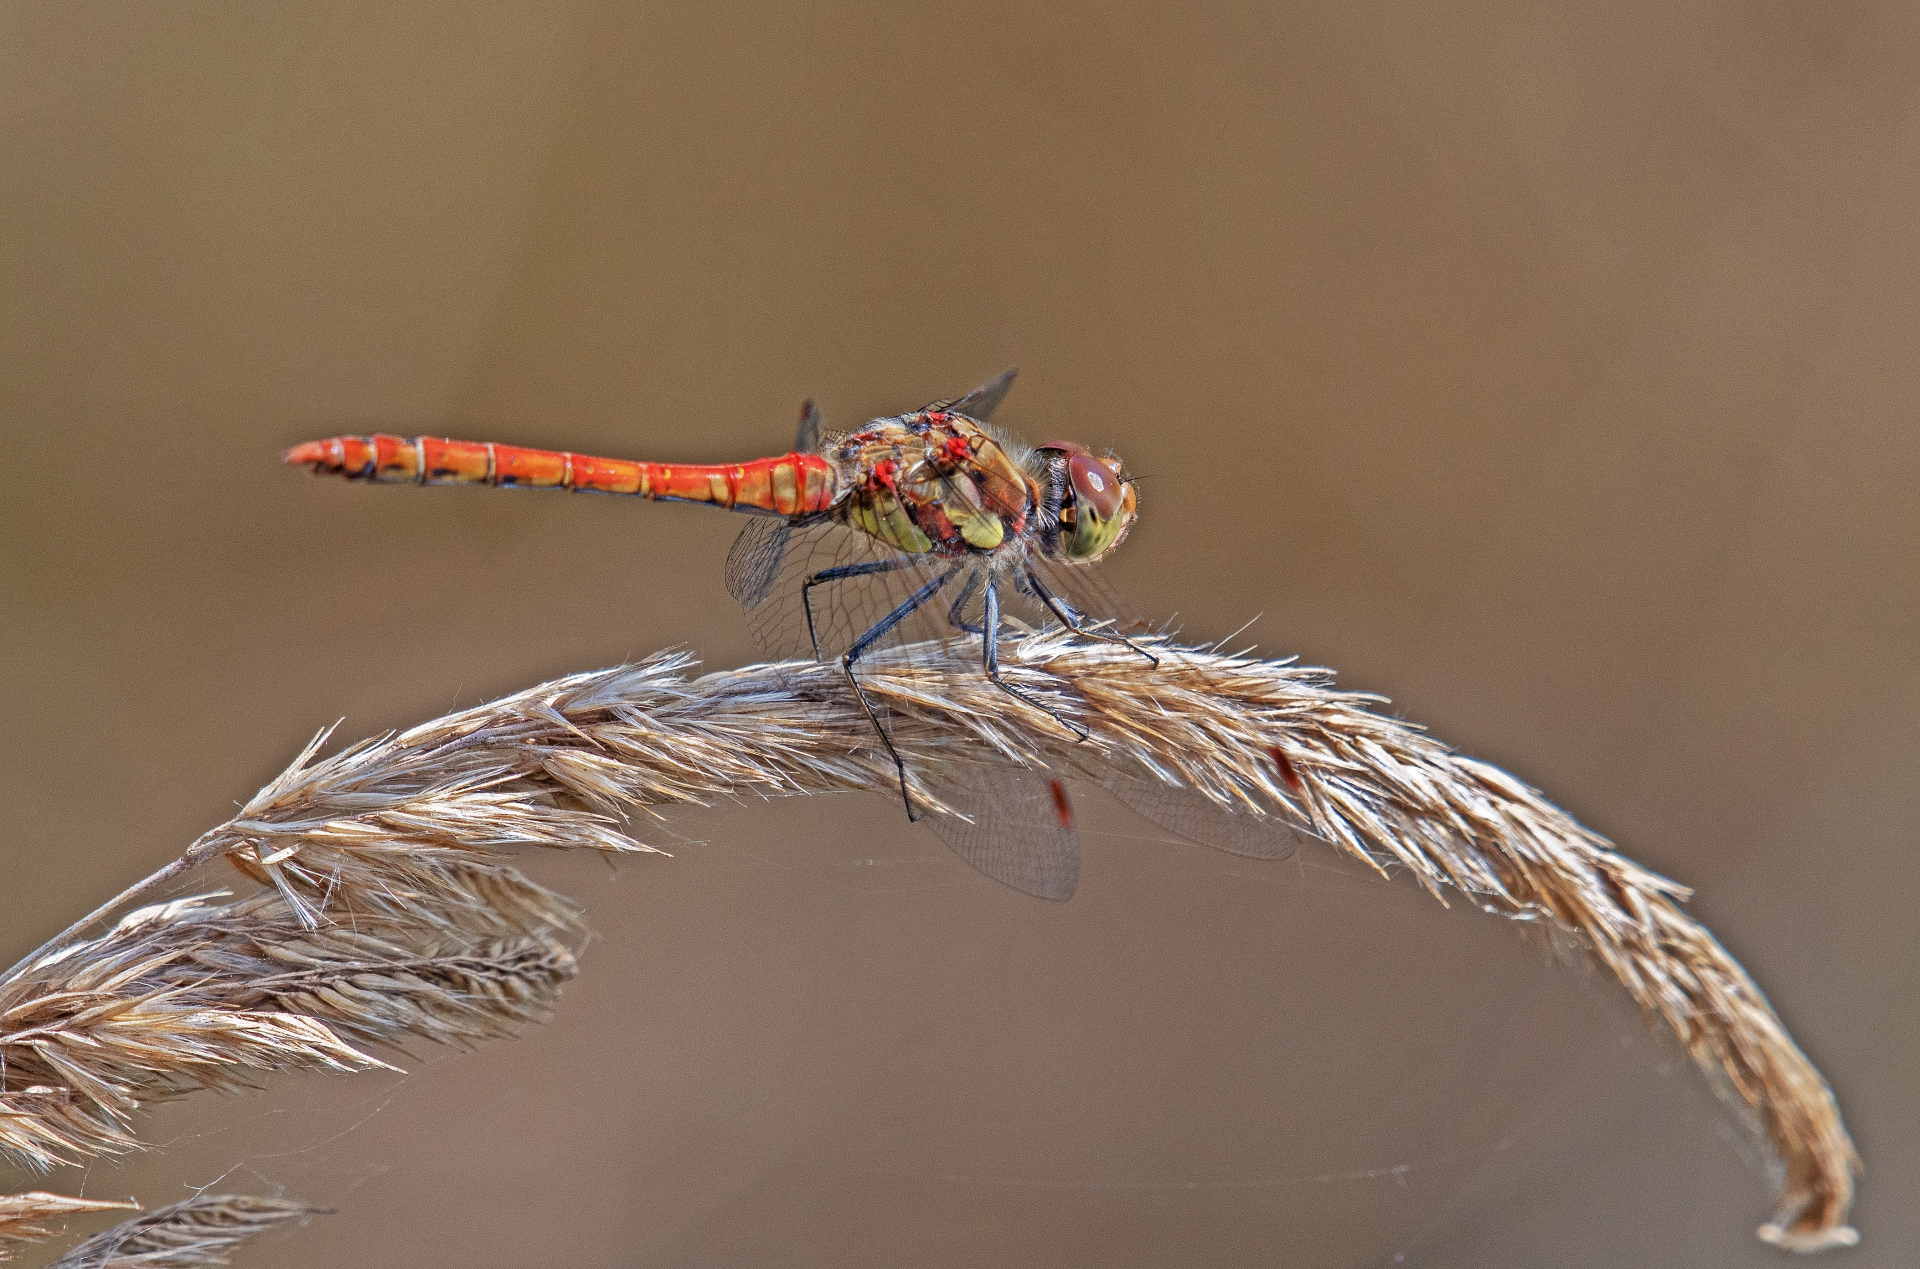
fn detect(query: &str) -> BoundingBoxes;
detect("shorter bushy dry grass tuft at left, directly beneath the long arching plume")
[0,864,578,1167]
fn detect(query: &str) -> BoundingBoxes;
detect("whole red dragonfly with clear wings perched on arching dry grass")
[284,371,1294,900]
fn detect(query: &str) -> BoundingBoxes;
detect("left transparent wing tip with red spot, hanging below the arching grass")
[925,766,1079,902]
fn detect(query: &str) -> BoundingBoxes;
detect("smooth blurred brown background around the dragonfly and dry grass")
[0,4,1920,1269]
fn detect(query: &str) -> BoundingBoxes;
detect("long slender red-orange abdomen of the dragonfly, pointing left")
[286,436,839,516]
